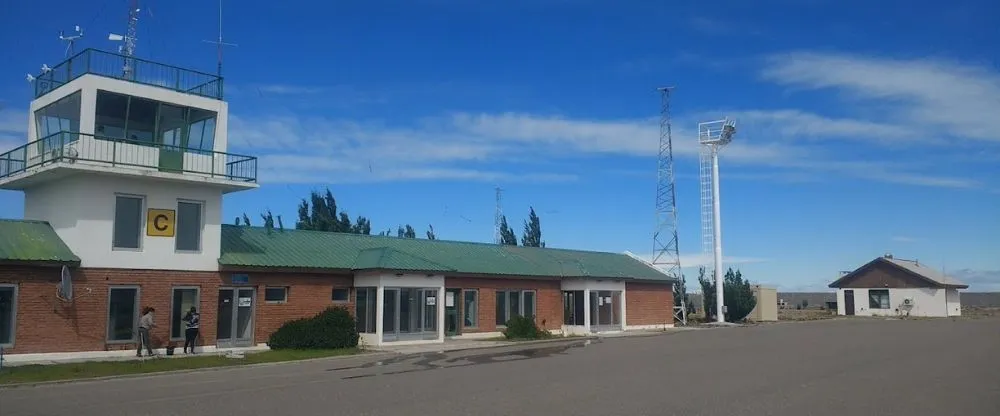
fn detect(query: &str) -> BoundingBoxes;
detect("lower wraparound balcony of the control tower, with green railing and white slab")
[0,132,257,190]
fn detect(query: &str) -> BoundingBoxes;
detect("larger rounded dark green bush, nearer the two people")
[267,307,358,350]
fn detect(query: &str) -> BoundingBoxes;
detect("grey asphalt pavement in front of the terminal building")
[0,319,1000,416]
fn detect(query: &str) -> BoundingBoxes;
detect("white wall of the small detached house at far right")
[837,288,961,317]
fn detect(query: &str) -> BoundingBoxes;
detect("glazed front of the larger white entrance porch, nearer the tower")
[382,287,438,342]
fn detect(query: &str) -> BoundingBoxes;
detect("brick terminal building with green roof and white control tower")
[0,49,674,360]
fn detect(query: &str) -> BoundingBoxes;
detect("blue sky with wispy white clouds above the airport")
[0,0,1000,290]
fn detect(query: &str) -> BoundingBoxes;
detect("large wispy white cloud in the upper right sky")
[762,52,1000,142]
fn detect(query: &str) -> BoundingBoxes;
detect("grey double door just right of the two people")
[216,287,257,348]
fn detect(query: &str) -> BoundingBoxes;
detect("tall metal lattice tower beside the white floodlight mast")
[652,87,681,279]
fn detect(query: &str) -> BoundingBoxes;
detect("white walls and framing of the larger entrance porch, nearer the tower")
[354,273,445,347]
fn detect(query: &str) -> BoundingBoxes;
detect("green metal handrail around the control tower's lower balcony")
[0,131,257,183]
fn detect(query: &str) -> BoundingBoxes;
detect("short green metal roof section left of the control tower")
[0,219,80,263]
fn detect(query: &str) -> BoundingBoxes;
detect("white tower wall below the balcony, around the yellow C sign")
[24,174,222,271]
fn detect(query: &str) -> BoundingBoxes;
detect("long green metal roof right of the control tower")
[219,225,672,281]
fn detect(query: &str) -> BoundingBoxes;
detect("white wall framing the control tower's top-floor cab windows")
[28,74,229,152]
